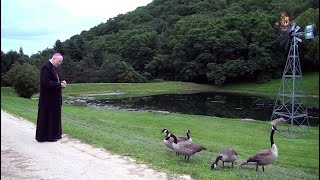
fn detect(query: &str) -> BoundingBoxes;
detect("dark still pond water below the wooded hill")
[82,92,319,126]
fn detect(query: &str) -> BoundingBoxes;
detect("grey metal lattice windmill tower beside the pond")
[271,20,315,138]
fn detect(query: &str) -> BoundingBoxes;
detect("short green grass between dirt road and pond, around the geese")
[1,86,319,180]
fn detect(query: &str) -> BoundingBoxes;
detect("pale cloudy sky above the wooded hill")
[1,0,152,56]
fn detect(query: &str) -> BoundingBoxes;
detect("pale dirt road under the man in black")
[1,110,190,180]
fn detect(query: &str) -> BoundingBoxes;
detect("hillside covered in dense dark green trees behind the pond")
[1,0,319,86]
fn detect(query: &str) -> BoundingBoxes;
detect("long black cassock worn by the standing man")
[36,61,62,142]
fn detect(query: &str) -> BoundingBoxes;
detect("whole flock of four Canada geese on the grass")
[161,125,278,171]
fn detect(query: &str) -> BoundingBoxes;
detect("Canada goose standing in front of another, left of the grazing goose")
[169,133,206,162]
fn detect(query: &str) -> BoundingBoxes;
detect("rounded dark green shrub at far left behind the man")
[4,63,39,98]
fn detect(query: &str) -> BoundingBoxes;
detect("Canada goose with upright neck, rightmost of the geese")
[241,126,278,171]
